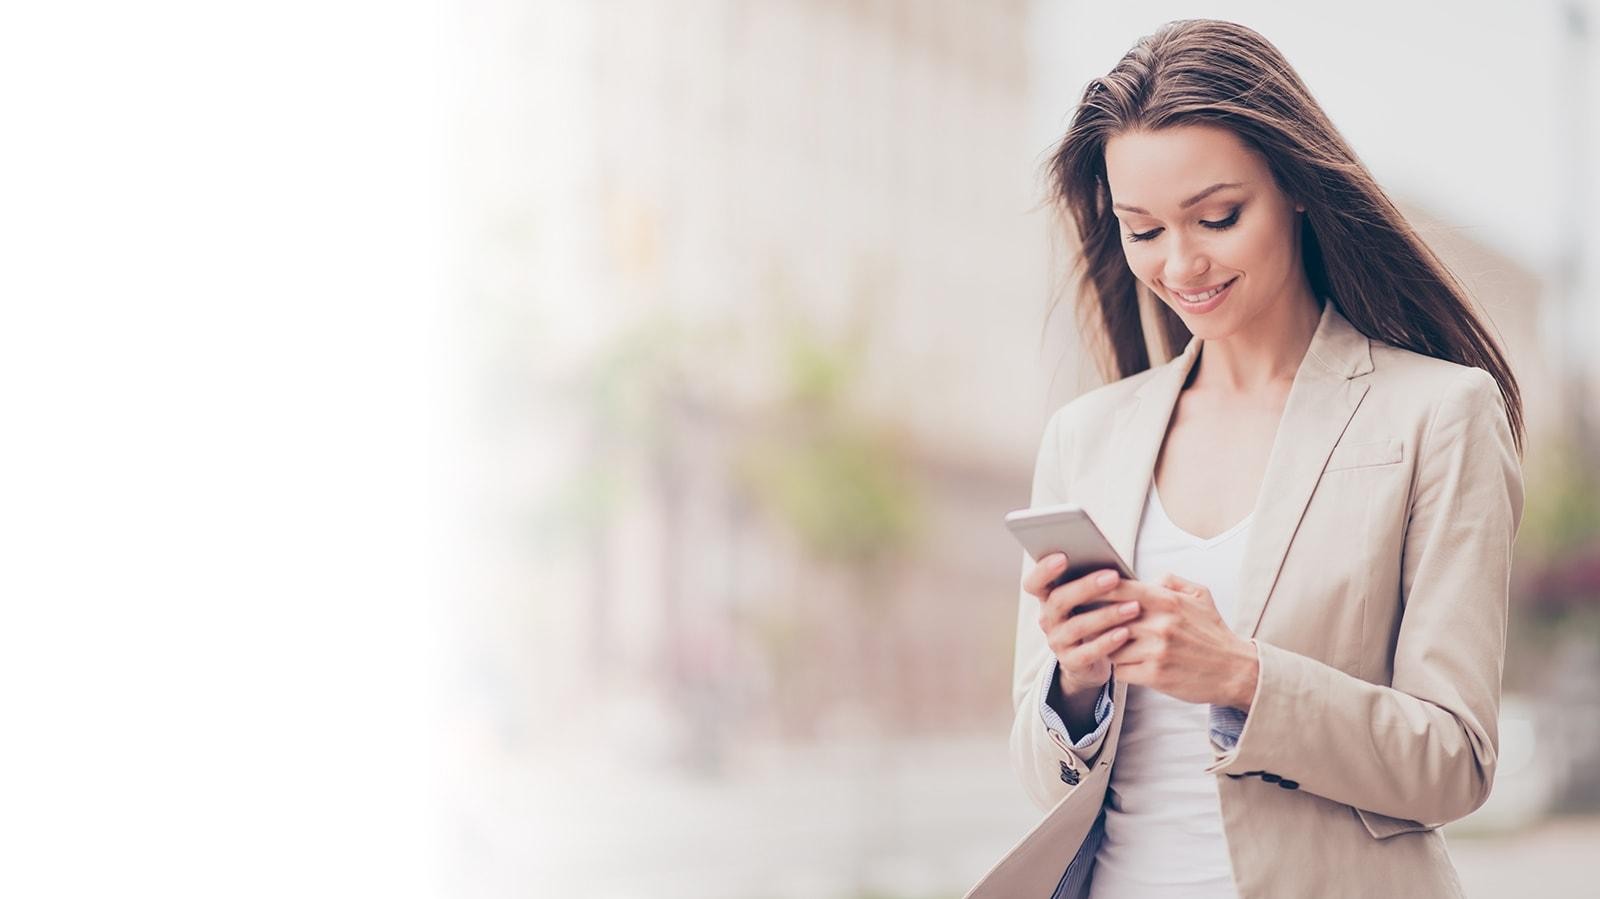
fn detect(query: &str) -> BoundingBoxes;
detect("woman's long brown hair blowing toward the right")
[1046,19,1523,451]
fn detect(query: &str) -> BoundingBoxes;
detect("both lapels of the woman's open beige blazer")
[1083,302,1373,636]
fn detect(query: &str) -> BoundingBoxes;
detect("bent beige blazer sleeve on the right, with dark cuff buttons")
[1206,368,1523,827]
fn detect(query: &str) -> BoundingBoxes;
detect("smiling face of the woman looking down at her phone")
[1106,125,1314,339]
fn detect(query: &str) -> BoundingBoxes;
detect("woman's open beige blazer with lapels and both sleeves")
[968,302,1523,899]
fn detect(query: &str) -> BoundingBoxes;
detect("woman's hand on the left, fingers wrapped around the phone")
[1022,552,1139,696]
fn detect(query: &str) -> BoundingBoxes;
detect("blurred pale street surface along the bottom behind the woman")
[451,739,1600,899]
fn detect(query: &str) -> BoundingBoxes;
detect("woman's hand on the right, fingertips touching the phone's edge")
[1104,574,1259,712]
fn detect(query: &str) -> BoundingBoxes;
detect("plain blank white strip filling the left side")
[0,0,448,896]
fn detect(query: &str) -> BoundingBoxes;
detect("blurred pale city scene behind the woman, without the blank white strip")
[467,0,1600,897]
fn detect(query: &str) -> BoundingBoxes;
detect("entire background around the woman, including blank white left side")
[0,0,1600,899]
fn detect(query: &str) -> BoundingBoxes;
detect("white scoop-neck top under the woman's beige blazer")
[1090,478,1254,899]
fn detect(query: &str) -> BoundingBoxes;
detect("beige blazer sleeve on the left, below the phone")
[1011,406,1110,811]
